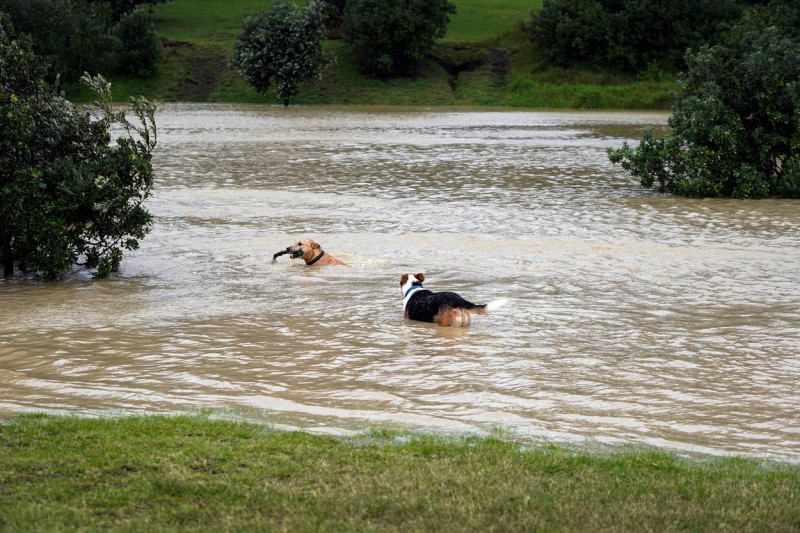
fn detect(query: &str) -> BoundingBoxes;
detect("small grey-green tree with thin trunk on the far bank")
[231,0,332,106]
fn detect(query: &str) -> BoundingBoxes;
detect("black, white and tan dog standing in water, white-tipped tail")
[400,273,507,328]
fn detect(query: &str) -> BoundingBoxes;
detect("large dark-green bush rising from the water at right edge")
[608,0,800,198]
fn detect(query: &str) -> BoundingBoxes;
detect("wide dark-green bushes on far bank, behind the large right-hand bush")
[530,0,741,73]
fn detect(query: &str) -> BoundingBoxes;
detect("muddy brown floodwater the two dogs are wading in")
[0,104,800,461]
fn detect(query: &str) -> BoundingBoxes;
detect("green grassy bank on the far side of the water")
[66,0,675,109]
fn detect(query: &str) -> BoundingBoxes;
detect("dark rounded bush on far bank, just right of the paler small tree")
[344,0,456,78]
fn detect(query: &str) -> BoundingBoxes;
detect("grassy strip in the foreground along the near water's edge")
[0,416,800,531]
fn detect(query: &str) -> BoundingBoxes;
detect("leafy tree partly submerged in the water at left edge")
[0,14,156,280]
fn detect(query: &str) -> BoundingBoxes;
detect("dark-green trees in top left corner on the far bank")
[0,0,165,81]
